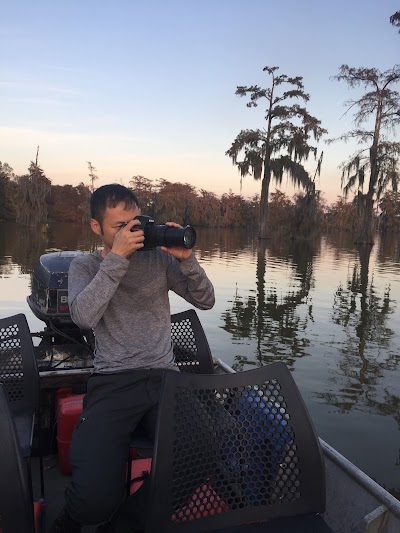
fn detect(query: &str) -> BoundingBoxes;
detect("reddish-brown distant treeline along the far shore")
[0,158,400,233]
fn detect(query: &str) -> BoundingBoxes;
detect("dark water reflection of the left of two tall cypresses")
[222,240,320,370]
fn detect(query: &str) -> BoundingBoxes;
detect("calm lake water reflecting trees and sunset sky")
[0,223,400,492]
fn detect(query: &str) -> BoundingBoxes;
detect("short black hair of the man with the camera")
[90,183,140,225]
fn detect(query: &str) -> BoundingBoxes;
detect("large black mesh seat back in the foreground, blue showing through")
[148,363,325,532]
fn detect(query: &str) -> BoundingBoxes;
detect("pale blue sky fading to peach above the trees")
[0,0,400,202]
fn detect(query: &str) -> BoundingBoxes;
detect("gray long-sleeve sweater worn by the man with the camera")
[68,249,215,373]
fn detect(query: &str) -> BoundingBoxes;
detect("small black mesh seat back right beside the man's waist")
[171,309,214,374]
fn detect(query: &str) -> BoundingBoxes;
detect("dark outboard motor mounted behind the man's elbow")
[27,251,94,364]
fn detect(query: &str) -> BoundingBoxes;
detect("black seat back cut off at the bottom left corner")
[0,384,34,533]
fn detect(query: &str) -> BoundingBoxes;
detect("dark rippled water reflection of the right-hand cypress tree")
[328,246,400,426]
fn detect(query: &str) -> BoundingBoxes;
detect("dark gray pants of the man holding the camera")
[66,369,167,531]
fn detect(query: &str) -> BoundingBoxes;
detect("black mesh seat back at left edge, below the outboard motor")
[0,314,39,412]
